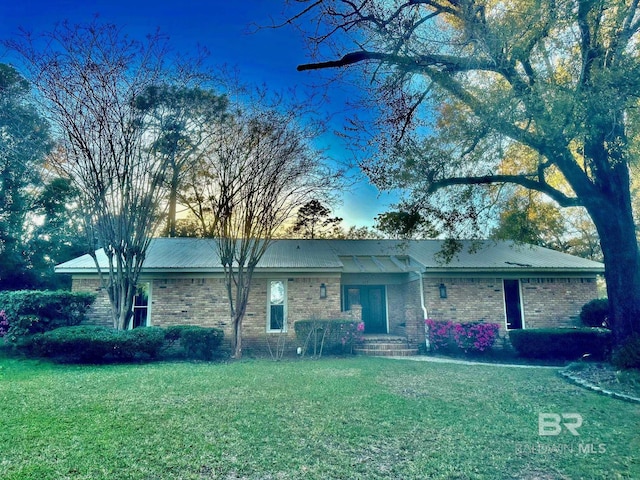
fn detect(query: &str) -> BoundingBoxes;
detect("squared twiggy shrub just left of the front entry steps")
[294,319,364,356]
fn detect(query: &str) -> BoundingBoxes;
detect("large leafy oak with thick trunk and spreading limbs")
[296,0,640,342]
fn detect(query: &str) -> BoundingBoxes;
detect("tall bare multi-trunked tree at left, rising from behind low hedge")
[9,20,200,329]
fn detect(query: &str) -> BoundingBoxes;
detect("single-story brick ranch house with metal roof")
[56,238,604,354]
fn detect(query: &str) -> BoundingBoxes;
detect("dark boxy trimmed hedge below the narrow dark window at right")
[509,328,612,360]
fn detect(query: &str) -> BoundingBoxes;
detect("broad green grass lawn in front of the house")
[0,358,640,480]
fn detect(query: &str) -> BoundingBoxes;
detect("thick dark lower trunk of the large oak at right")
[587,195,640,345]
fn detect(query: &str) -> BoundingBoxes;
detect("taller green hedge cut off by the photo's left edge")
[0,290,96,342]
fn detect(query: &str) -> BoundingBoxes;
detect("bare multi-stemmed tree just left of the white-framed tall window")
[183,94,339,358]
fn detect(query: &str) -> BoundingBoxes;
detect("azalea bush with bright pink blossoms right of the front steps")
[425,318,500,353]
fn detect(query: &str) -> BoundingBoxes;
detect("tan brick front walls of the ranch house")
[73,273,597,355]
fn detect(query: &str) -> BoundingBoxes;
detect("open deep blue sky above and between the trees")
[0,0,396,227]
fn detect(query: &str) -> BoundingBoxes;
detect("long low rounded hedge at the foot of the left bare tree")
[18,325,165,363]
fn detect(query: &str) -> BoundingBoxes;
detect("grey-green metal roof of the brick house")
[56,238,604,274]
